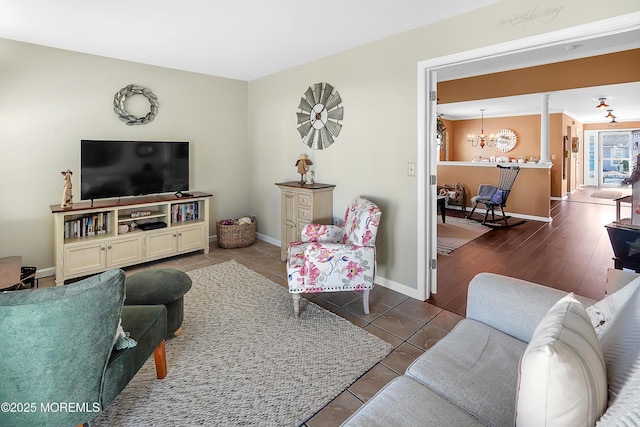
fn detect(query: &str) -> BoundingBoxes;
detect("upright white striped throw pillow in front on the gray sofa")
[516,294,607,427]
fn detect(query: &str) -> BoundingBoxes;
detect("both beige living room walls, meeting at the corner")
[0,0,639,289]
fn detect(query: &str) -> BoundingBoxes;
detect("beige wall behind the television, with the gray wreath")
[0,39,251,270]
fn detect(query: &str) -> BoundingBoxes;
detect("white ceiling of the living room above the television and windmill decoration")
[0,0,498,80]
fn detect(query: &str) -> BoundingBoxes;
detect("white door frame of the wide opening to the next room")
[416,12,640,301]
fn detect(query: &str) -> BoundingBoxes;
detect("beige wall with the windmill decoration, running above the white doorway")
[248,0,640,289]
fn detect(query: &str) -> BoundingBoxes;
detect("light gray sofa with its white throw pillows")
[343,273,640,427]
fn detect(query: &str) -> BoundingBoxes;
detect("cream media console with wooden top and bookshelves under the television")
[50,192,212,286]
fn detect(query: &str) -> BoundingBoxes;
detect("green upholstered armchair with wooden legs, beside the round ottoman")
[0,270,167,426]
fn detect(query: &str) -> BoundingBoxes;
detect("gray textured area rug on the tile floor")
[91,261,392,426]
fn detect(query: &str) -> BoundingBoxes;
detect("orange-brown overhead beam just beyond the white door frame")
[438,49,640,104]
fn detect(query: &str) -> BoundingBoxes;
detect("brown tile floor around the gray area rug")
[39,240,462,427]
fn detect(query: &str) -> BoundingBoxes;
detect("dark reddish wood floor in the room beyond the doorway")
[429,189,628,315]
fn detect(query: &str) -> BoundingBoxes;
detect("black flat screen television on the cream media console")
[80,139,189,200]
